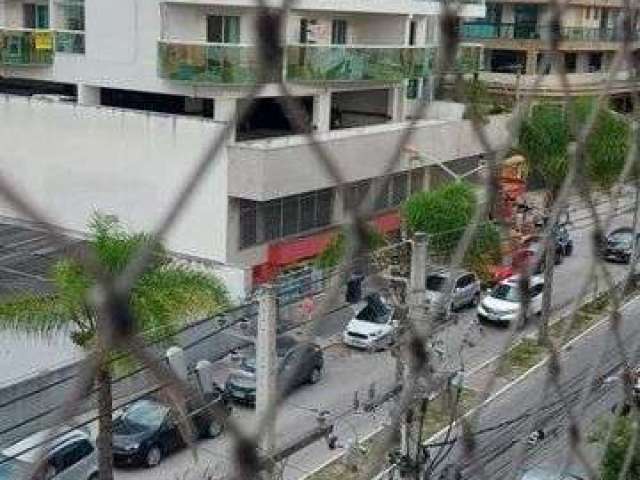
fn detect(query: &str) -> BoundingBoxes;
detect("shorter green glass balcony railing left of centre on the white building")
[158,40,276,85]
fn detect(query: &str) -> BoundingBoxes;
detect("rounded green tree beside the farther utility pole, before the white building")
[403,182,500,275]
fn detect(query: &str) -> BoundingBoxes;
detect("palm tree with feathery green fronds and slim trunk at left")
[0,213,229,480]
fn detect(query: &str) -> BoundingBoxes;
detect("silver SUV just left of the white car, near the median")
[425,269,481,310]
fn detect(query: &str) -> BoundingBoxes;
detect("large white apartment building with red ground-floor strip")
[0,0,503,296]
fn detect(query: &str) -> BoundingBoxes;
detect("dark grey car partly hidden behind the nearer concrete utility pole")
[225,342,324,405]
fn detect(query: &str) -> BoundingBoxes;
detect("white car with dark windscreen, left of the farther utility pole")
[342,293,397,349]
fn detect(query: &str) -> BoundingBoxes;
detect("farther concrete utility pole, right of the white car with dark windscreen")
[396,232,427,476]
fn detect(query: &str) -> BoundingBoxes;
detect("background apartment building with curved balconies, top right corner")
[461,0,636,96]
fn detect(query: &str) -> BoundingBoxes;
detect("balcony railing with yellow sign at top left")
[0,28,54,66]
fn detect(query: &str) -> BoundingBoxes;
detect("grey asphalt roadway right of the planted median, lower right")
[430,292,640,479]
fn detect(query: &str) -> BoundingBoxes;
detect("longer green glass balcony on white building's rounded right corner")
[287,45,435,82]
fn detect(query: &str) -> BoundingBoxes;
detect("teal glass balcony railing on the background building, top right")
[461,23,623,42]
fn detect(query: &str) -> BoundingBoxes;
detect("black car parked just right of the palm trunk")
[113,391,230,467]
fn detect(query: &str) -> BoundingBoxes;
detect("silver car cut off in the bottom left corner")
[0,430,98,480]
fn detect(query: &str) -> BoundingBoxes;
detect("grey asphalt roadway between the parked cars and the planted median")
[111,203,632,480]
